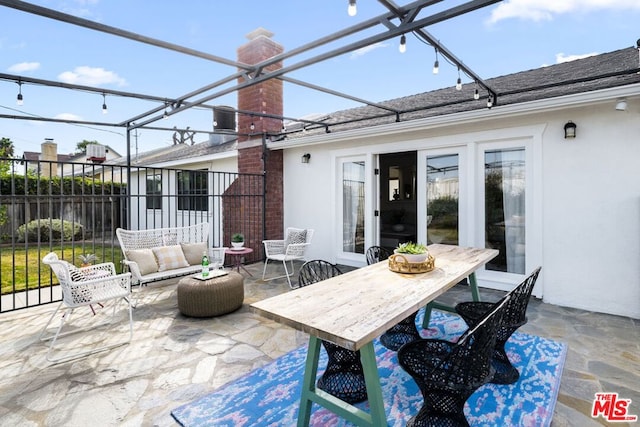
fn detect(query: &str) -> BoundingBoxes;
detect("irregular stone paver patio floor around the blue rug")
[0,263,640,427]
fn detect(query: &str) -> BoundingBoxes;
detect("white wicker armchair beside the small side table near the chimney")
[262,227,313,288]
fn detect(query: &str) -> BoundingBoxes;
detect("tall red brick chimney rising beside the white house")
[230,28,284,247]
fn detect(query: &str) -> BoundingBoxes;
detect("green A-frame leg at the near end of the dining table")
[298,336,387,427]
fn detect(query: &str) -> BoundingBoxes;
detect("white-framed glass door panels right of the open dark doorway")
[417,141,532,283]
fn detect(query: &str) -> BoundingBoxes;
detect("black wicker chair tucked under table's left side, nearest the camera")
[298,260,367,403]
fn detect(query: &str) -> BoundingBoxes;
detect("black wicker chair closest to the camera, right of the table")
[398,296,510,427]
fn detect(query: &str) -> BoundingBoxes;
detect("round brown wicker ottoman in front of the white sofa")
[178,271,244,317]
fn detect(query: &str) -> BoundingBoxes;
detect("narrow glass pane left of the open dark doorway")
[342,161,365,254]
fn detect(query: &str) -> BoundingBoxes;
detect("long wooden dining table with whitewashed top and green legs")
[250,244,498,427]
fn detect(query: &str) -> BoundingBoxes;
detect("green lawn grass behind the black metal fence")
[0,244,122,295]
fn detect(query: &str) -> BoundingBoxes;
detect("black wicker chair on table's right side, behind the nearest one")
[455,267,542,384]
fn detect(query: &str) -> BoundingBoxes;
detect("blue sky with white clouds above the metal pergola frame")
[0,0,640,159]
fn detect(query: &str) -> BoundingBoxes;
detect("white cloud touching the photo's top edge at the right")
[488,0,640,24]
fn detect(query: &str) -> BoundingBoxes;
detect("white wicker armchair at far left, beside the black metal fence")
[39,252,133,362]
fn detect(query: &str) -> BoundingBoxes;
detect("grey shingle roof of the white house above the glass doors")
[283,48,640,139]
